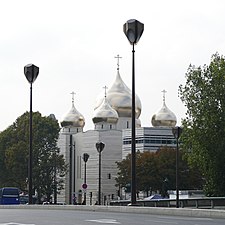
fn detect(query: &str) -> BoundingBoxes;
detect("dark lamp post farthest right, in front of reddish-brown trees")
[172,127,182,208]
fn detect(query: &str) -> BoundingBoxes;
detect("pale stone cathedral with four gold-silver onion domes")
[58,57,177,205]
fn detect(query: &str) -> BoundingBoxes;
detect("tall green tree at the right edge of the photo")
[179,53,225,196]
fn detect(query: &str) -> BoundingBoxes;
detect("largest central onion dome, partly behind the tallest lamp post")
[95,69,141,118]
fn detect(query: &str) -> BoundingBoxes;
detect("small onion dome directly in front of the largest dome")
[92,97,119,124]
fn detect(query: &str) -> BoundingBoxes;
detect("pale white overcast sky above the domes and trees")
[0,0,225,131]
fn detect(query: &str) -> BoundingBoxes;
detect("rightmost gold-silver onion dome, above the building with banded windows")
[152,91,177,127]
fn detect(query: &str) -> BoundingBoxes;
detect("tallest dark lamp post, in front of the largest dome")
[123,19,144,205]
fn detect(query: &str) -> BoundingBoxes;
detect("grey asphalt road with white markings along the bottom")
[0,209,225,225]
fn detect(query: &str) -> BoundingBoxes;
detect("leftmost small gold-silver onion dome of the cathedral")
[61,96,85,127]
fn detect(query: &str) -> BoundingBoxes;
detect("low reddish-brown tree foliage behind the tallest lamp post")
[116,147,202,195]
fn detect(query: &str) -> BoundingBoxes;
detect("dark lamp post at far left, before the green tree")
[24,64,39,204]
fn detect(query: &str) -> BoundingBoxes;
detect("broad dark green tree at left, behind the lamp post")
[0,112,67,200]
